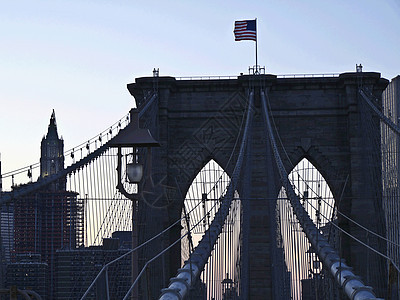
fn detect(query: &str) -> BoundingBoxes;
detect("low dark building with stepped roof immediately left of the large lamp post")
[54,238,132,300]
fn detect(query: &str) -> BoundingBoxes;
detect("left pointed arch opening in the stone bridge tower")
[181,159,242,295]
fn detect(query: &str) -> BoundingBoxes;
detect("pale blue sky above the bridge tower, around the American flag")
[0,0,400,172]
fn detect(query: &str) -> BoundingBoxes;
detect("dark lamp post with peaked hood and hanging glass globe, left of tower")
[110,108,160,299]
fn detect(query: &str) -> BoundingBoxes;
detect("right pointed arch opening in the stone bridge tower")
[277,157,338,299]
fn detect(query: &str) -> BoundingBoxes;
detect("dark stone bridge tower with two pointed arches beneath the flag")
[128,72,388,299]
